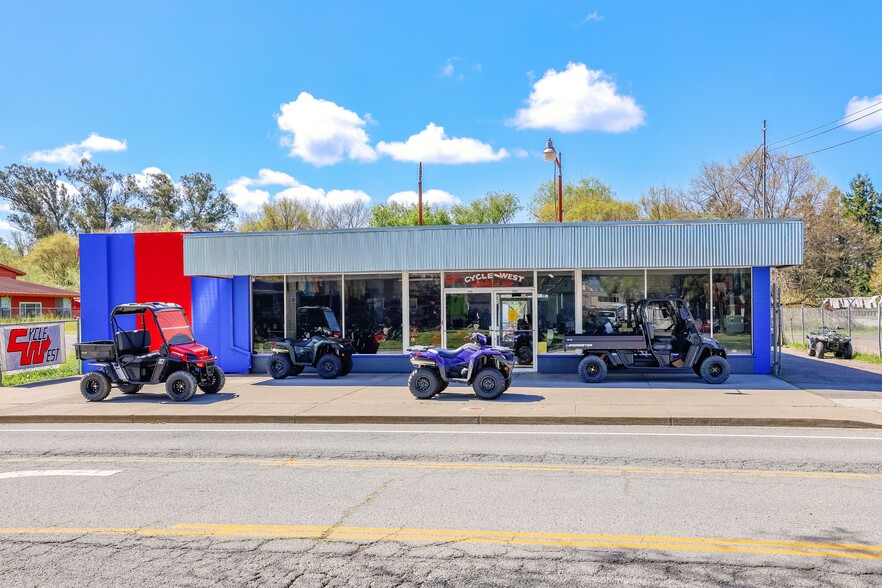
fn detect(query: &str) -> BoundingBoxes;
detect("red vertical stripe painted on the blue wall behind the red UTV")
[135,233,193,349]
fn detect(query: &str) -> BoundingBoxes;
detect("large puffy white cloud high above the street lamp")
[511,63,646,133]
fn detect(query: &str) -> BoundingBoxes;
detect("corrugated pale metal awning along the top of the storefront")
[184,219,803,276]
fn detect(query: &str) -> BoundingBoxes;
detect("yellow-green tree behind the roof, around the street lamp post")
[531,177,639,222]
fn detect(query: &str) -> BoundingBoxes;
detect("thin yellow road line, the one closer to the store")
[0,457,882,481]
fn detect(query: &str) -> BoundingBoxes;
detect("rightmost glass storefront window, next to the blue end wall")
[712,268,753,353]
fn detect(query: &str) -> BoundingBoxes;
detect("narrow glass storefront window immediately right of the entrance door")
[530,272,576,353]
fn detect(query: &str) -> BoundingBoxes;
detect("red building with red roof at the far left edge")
[0,263,80,317]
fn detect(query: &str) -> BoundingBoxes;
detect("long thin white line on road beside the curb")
[0,427,882,441]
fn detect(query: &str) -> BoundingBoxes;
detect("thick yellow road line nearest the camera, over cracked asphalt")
[0,524,882,561]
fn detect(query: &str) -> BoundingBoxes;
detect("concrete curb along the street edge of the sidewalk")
[0,415,882,429]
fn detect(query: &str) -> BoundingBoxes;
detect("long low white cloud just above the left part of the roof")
[227,168,371,213]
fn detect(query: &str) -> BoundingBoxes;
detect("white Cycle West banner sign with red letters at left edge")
[0,323,67,372]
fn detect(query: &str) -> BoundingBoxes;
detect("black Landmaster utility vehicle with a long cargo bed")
[564,297,731,384]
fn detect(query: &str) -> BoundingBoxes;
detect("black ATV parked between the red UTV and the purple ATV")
[266,306,355,380]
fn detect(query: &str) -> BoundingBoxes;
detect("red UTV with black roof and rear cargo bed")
[75,302,226,402]
